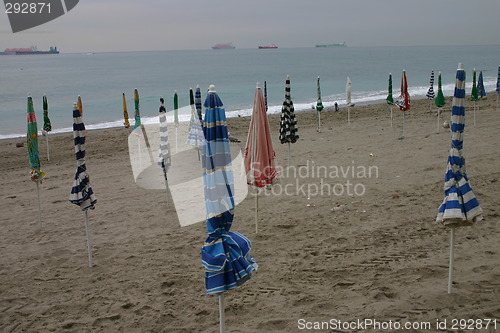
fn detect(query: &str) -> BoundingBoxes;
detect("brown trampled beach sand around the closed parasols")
[0,94,500,332]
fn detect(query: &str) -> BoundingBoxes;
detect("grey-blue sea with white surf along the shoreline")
[0,45,500,139]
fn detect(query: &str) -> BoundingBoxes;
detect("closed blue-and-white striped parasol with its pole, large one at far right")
[436,64,483,293]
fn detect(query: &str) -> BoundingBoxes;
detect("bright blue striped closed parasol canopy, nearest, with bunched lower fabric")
[202,86,257,294]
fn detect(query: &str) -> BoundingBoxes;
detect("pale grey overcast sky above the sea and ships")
[0,0,500,53]
